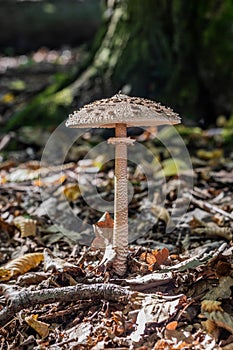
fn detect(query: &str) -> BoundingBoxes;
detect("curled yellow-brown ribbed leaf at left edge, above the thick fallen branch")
[0,253,44,281]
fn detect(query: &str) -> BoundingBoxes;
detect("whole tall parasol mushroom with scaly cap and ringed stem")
[66,93,180,276]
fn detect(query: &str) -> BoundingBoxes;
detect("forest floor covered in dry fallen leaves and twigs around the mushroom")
[0,51,233,350]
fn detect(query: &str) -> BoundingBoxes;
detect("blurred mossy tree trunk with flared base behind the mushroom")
[7,0,233,130]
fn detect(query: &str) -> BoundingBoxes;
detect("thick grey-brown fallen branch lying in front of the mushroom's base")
[0,283,137,326]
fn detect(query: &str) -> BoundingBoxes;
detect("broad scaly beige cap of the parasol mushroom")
[66,93,181,128]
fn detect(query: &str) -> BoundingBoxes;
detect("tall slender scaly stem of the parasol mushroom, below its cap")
[113,124,128,276]
